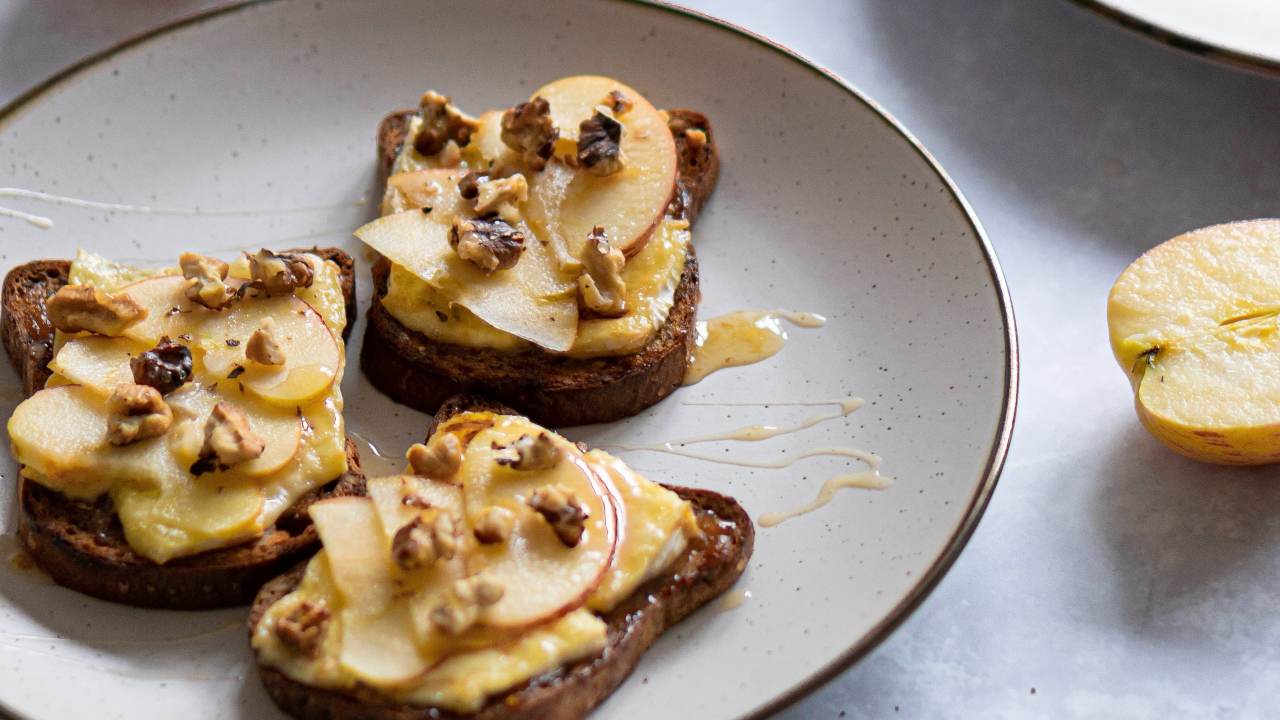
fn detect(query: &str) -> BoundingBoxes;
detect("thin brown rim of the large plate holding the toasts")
[0,0,1018,720]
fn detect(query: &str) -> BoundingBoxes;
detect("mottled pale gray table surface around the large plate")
[0,0,1280,719]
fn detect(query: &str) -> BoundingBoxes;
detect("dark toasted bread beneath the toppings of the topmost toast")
[360,110,719,427]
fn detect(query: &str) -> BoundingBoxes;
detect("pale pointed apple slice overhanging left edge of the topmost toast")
[356,210,577,351]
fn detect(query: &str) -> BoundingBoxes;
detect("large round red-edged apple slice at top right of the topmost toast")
[529,76,677,258]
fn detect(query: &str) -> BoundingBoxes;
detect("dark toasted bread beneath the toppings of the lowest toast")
[248,397,755,720]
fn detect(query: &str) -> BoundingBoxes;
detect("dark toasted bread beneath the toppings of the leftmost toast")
[0,249,365,610]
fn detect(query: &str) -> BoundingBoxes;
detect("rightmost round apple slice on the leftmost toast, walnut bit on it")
[192,296,343,407]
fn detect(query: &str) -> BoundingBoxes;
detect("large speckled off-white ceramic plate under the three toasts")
[0,0,1016,720]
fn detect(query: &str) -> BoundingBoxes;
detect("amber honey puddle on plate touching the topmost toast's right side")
[684,310,827,386]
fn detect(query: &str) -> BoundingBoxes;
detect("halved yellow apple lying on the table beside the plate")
[1107,220,1280,465]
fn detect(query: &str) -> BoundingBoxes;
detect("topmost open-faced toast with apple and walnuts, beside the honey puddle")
[356,76,719,425]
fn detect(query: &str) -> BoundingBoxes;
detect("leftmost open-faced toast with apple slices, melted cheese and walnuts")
[0,250,364,609]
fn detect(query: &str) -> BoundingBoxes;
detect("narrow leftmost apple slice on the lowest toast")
[308,497,429,685]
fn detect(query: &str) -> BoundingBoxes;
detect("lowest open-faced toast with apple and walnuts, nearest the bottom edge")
[250,397,754,720]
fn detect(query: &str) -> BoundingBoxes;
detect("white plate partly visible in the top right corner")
[1078,0,1280,73]
